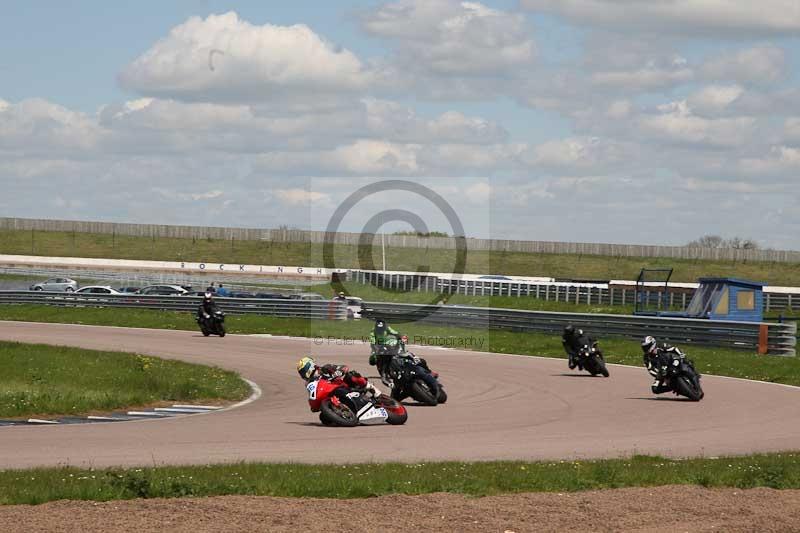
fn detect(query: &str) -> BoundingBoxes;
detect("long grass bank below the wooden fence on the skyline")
[0,230,800,285]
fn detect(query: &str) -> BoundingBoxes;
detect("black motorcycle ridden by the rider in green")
[387,352,447,406]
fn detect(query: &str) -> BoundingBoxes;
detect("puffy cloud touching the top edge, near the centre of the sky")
[362,0,536,75]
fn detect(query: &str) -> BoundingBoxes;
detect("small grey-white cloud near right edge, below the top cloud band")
[701,44,788,84]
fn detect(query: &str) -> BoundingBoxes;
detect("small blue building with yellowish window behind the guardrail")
[686,278,765,322]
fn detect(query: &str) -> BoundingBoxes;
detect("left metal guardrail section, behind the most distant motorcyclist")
[0,291,347,320]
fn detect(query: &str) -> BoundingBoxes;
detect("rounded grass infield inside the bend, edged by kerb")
[0,342,250,418]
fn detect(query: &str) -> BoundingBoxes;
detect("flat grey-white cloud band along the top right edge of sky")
[521,0,800,39]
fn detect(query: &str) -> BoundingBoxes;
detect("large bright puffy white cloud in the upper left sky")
[119,12,373,101]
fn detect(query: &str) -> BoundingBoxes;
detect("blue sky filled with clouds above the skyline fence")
[0,0,800,250]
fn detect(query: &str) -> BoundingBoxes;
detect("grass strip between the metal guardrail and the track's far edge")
[0,305,800,385]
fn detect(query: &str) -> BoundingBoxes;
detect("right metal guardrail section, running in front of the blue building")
[361,302,797,356]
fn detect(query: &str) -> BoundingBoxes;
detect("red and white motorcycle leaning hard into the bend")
[306,379,408,427]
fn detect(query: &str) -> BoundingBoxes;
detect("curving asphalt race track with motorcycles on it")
[0,322,800,468]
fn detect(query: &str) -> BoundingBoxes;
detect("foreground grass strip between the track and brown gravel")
[0,453,800,505]
